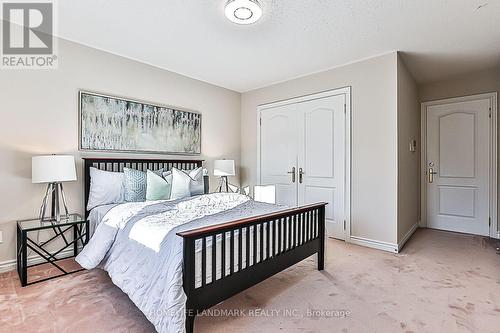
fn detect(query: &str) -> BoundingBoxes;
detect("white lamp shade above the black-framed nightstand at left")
[31,155,76,183]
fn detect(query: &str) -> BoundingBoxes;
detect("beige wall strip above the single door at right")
[419,67,500,232]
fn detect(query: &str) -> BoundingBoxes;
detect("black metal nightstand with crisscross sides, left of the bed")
[17,214,89,287]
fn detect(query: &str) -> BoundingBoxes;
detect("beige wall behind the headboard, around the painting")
[0,40,241,266]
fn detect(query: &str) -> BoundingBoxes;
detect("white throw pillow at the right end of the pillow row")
[171,167,204,199]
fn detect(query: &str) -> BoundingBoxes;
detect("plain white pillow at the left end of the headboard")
[87,167,125,210]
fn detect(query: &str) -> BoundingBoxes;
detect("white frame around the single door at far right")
[419,92,500,238]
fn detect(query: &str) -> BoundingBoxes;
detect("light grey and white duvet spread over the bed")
[76,193,280,333]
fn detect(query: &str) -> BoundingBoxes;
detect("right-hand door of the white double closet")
[297,95,345,239]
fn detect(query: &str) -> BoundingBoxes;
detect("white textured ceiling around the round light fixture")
[58,0,500,92]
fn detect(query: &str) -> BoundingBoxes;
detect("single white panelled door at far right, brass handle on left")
[426,99,491,236]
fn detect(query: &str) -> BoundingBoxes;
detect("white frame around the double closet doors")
[257,86,352,240]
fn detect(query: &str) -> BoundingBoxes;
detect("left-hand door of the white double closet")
[260,104,298,207]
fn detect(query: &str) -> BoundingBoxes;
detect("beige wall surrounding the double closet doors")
[241,53,397,244]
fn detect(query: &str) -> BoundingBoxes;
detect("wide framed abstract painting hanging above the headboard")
[79,91,201,155]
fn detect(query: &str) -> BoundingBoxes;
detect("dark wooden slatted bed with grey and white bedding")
[80,158,326,333]
